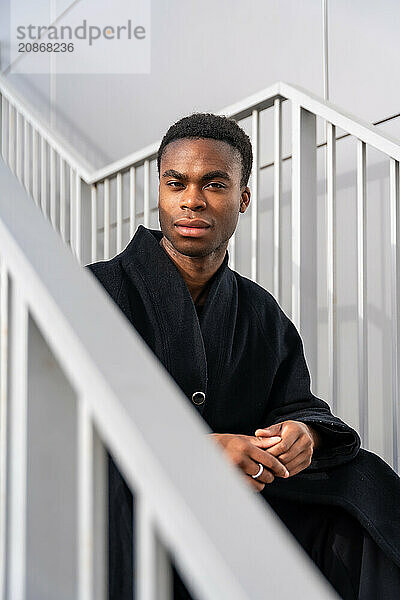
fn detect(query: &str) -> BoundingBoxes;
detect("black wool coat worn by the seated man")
[89,225,400,566]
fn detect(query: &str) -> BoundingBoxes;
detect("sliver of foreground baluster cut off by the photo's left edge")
[0,259,8,600]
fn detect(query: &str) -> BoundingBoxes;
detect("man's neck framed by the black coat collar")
[160,236,226,305]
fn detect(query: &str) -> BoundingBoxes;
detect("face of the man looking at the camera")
[158,138,250,256]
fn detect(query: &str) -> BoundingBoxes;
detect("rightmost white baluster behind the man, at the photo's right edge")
[390,158,400,472]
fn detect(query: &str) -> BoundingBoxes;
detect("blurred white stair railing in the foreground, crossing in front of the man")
[0,158,336,600]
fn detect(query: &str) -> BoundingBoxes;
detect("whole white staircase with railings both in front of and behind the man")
[0,77,400,600]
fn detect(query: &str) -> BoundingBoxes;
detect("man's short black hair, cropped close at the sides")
[157,113,253,187]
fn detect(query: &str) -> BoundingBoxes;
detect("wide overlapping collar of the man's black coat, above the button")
[121,225,237,412]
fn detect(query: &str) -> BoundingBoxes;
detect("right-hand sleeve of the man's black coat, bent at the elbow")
[266,309,361,471]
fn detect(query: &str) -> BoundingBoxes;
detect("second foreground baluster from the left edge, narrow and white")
[7,281,28,600]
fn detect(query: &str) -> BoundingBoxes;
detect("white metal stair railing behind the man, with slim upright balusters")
[0,77,400,471]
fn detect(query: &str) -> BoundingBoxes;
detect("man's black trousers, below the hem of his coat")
[174,498,400,600]
